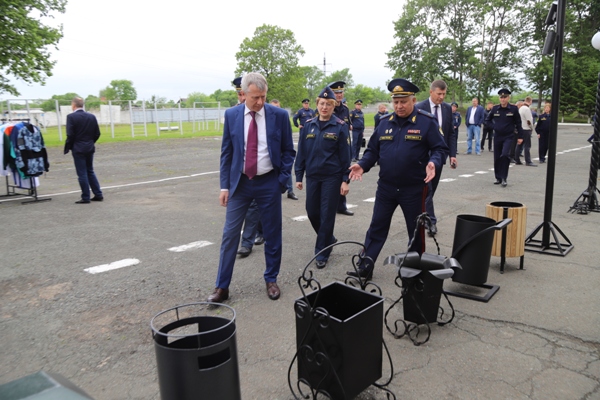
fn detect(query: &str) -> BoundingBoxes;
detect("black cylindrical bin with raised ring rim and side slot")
[150,303,241,400]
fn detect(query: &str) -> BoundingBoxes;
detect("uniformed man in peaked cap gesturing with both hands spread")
[348,79,449,279]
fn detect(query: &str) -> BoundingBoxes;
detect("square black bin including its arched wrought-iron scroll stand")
[288,241,396,400]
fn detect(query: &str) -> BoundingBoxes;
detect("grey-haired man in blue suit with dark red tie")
[208,72,296,303]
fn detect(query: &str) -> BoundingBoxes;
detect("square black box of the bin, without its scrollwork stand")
[294,282,383,399]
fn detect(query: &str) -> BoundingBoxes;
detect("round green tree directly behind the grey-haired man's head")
[235,24,306,106]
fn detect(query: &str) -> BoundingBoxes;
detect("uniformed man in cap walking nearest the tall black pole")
[486,89,523,187]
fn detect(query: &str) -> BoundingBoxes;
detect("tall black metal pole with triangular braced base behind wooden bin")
[525,0,573,256]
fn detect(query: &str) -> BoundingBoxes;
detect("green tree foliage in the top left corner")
[0,0,66,96]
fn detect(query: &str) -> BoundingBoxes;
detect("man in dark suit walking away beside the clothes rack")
[65,97,104,204]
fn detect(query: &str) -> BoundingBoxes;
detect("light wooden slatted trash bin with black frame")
[485,201,527,273]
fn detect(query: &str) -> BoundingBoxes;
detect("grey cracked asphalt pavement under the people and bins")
[0,125,600,400]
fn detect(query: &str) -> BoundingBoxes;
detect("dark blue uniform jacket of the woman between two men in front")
[294,116,350,183]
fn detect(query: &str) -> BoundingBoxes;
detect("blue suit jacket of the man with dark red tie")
[220,104,296,197]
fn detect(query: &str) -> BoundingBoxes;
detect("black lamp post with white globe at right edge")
[570,32,600,214]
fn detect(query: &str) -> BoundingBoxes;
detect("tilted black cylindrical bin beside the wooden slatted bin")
[452,215,496,285]
